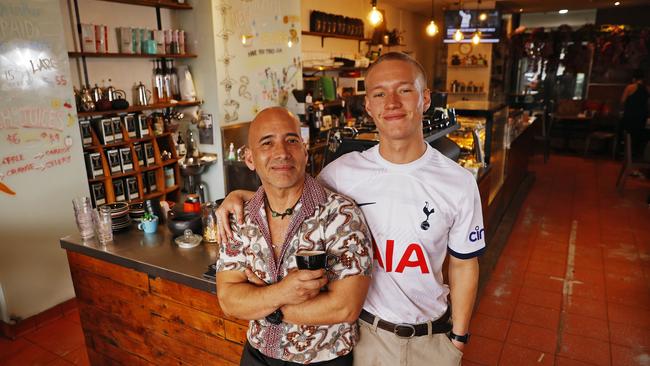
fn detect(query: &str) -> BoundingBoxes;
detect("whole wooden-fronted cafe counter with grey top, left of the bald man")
[61,226,248,365]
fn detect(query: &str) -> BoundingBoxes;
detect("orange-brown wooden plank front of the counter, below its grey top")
[67,250,248,366]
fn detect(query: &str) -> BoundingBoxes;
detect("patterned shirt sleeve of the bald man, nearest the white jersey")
[326,196,373,281]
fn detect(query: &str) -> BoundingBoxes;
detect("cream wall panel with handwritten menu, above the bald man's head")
[215,0,302,123]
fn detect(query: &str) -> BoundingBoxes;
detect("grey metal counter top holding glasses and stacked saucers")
[60,225,219,293]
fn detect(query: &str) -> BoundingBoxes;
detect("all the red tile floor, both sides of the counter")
[0,155,650,366]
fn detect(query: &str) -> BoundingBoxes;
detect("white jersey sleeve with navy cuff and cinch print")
[447,177,485,259]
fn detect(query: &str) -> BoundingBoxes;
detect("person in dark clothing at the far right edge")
[621,69,649,159]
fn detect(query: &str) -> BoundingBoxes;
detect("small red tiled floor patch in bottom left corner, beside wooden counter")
[0,309,90,366]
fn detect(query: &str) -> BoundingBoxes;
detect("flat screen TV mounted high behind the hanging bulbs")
[444,9,501,43]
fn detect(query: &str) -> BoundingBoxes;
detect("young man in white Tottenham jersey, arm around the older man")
[220,53,485,366]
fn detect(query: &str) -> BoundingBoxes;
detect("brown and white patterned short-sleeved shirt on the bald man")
[217,176,372,364]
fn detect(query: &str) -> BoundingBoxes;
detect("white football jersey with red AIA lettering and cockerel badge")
[318,144,485,324]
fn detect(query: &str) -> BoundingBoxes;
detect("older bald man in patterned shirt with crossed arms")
[217,108,372,366]
